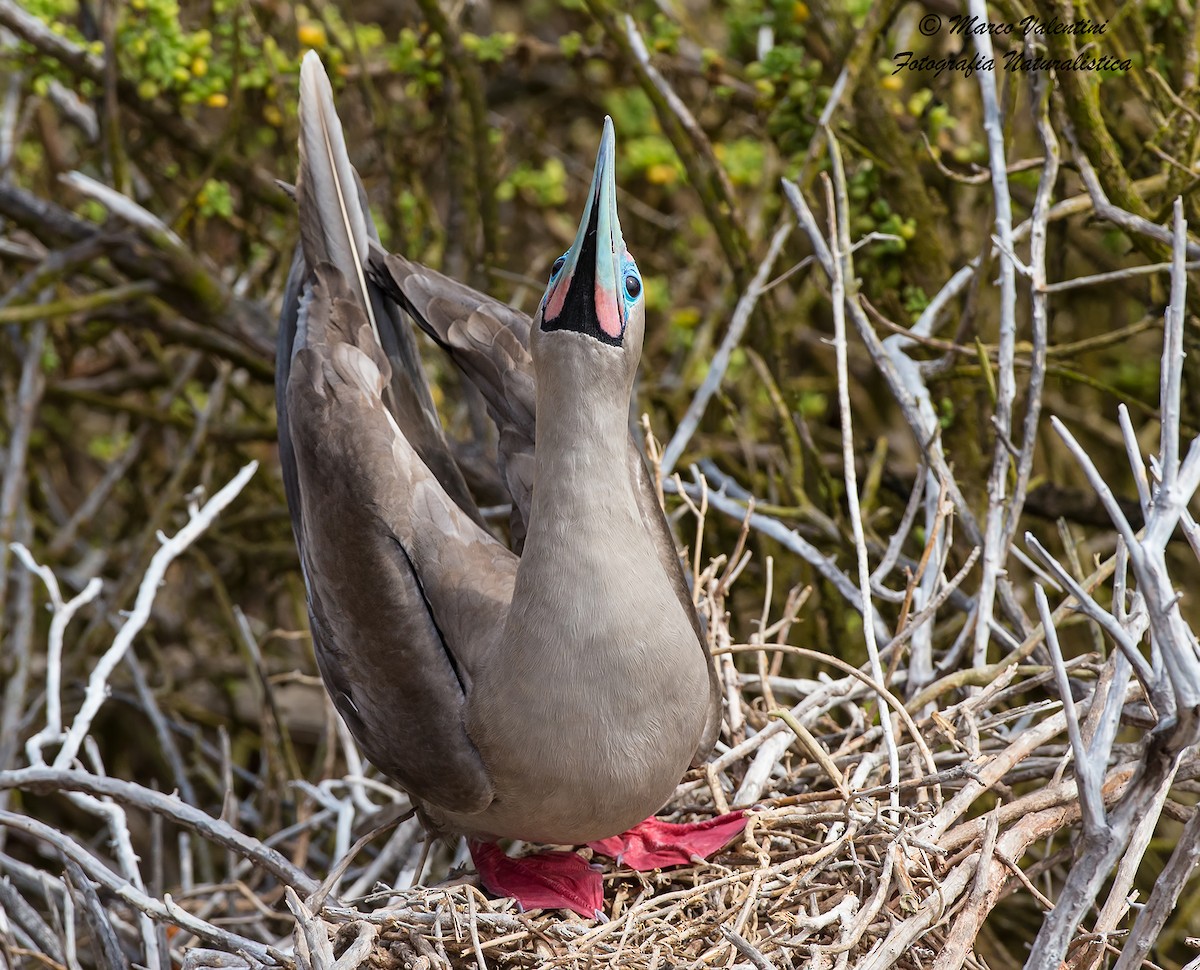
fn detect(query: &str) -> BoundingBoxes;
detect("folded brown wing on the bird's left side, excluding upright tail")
[286,263,516,813]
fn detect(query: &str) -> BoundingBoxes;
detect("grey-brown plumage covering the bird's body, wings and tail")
[277,54,719,843]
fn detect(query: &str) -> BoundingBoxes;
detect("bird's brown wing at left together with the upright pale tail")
[276,55,517,813]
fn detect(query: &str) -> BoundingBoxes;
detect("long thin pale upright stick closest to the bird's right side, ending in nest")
[826,144,907,818]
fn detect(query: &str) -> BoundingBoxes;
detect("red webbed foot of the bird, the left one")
[467,839,604,920]
